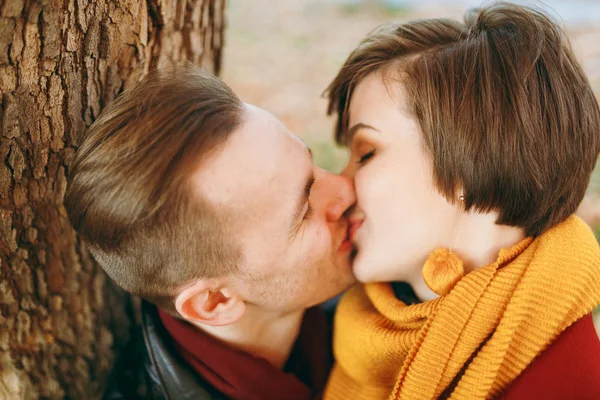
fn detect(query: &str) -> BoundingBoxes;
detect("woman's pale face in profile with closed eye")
[344,72,459,282]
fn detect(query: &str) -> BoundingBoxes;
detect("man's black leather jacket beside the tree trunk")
[102,301,226,400]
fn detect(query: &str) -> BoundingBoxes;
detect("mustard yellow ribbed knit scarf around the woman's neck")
[325,216,600,400]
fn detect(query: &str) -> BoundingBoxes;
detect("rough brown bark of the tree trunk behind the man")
[0,0,225,399]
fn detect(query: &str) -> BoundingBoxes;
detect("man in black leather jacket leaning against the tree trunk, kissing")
[65,66,355,399]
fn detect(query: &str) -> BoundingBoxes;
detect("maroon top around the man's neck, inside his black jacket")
[159,307,332,400]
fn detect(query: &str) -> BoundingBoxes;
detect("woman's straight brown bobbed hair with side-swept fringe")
[327,2,600,236]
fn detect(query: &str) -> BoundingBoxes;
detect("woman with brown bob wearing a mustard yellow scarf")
[325,3,600,400]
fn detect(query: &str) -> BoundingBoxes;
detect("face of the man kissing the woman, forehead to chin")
[194,105,355,312]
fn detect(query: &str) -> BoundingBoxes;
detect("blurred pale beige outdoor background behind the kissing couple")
[223,0,600,233]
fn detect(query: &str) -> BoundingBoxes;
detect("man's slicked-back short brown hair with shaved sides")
[65,65,243,312]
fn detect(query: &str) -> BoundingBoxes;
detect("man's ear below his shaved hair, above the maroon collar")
[175,280,246,326]
